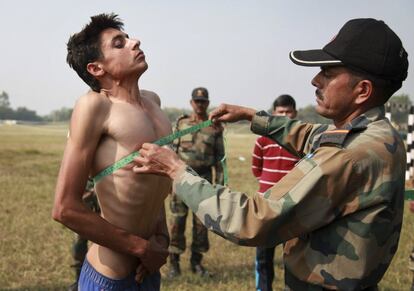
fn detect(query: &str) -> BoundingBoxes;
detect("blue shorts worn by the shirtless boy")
[78,259,161,291]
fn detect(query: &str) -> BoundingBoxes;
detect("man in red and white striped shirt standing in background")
[252,94,299,291]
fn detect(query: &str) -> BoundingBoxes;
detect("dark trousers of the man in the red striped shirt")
[255,247,276,291]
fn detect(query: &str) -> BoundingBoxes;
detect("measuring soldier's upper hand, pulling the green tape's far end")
[209,104,256,123]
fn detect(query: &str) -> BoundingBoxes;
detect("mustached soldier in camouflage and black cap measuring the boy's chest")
[136,19,408,291]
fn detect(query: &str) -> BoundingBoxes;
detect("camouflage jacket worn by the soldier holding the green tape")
[173,106,406,290]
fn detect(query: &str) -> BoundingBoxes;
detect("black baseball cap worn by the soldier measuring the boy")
[289,18,408,82]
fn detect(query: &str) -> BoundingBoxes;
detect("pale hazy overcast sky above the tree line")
[0,0,414,115]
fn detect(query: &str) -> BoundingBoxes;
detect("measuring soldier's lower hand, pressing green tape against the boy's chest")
[132,143,185,179]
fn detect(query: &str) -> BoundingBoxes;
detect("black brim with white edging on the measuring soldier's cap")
[289,50,343,67]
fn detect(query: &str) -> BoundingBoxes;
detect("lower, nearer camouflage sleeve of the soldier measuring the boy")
[174,147,362,246]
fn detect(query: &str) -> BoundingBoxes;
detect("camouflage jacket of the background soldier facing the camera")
[174,115,224,184]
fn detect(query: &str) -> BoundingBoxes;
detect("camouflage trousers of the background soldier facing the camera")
[169,171,212,254]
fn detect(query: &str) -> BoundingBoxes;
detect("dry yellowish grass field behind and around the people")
[0,125,414,291]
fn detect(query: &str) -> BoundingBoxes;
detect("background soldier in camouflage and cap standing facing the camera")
[169,87,224,278]
